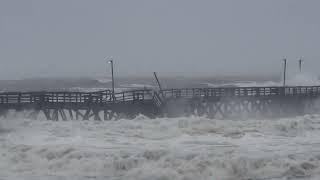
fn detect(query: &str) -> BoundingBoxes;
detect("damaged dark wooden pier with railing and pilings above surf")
[0,86,320,121]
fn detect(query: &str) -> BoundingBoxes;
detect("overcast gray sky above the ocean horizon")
[0,0,320,79]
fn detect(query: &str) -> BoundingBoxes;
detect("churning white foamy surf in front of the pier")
[0,115,320,180]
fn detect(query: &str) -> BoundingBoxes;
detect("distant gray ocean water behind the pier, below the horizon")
[0,73,320,92]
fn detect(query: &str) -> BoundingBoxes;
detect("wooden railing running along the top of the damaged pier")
[0,86,320,106]
